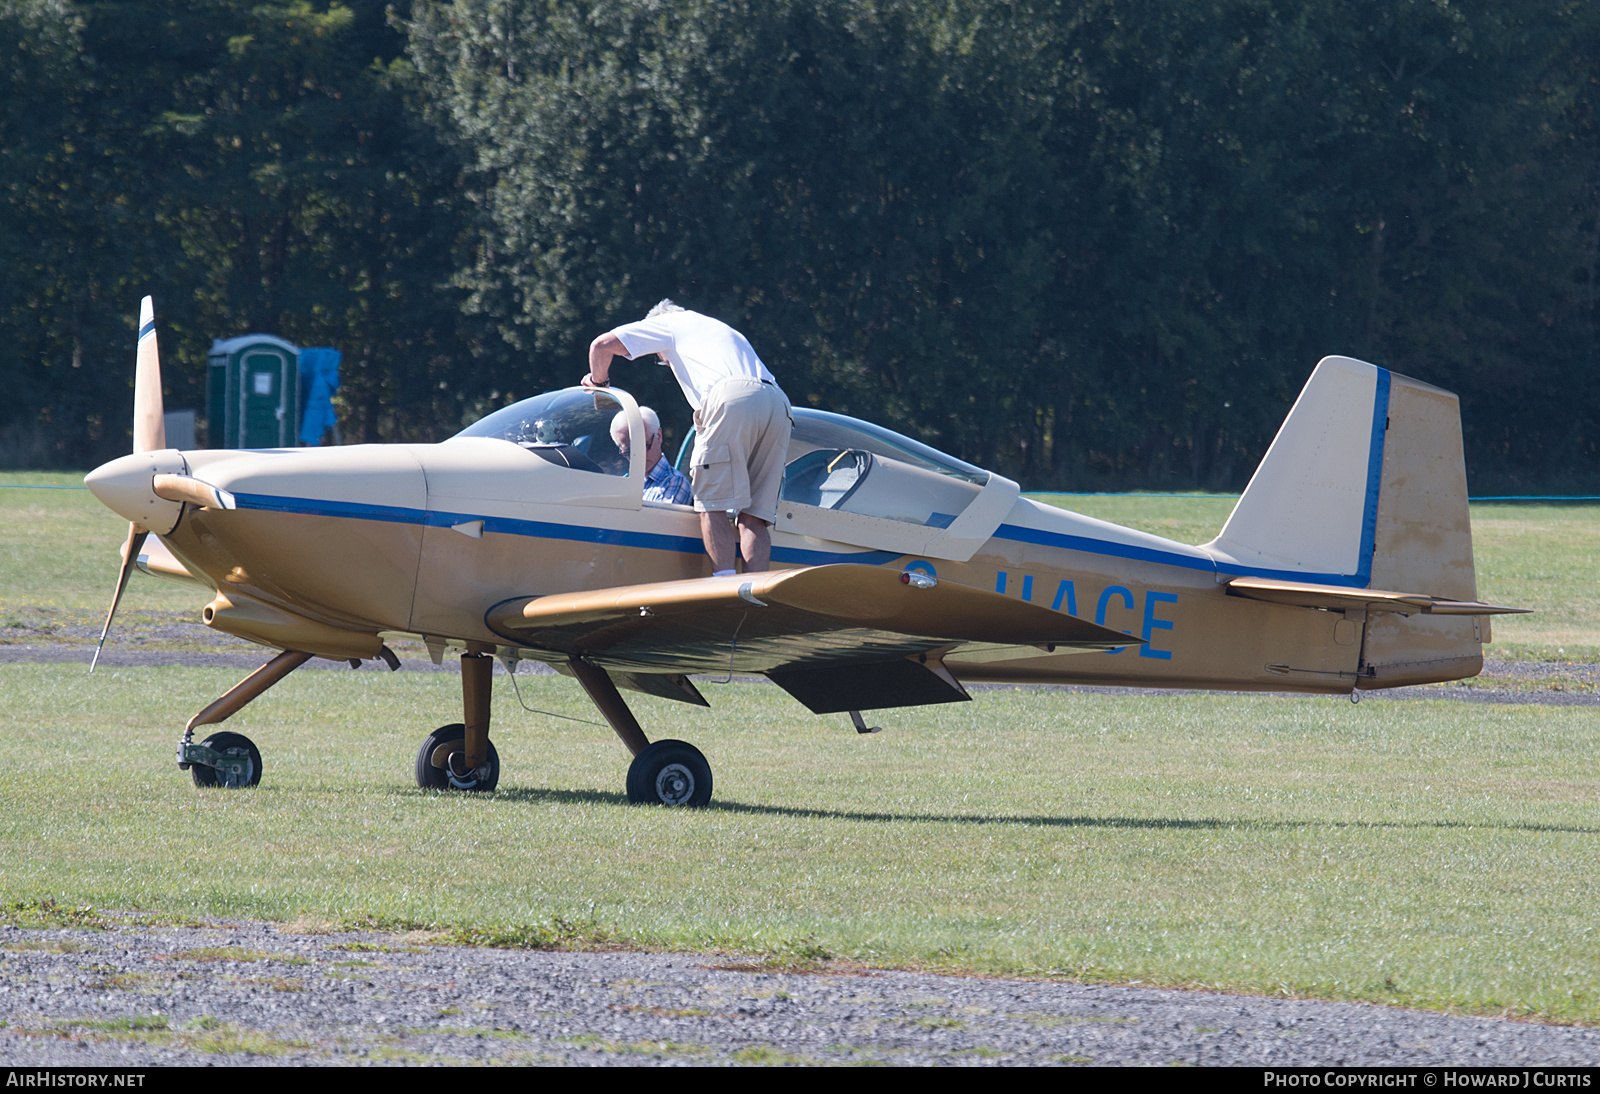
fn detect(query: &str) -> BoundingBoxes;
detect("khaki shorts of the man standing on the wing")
[690,379,794,525]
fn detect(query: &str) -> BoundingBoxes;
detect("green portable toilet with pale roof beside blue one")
[205,334,299,448]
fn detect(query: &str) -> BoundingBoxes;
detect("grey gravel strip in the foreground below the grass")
[0,916,1600,1067]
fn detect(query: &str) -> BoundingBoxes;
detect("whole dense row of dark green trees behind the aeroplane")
[0,0,1600,489]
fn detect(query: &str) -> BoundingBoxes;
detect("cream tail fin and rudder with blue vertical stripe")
[1205,357,1488,688]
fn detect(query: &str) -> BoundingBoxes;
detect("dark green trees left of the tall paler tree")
[0,0,461,464]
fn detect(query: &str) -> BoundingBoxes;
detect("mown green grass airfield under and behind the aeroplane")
[0,477,1600,1022]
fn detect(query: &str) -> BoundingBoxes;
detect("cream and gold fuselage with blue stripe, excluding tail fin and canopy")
[109,438,1477,693]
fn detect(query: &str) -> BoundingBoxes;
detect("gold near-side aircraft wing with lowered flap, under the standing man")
[485,565,1139,713]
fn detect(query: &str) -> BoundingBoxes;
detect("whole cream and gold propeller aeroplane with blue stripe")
[86,297,1518,805]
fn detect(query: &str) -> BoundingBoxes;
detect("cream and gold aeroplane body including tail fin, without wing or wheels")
[88,358,1498,693]
